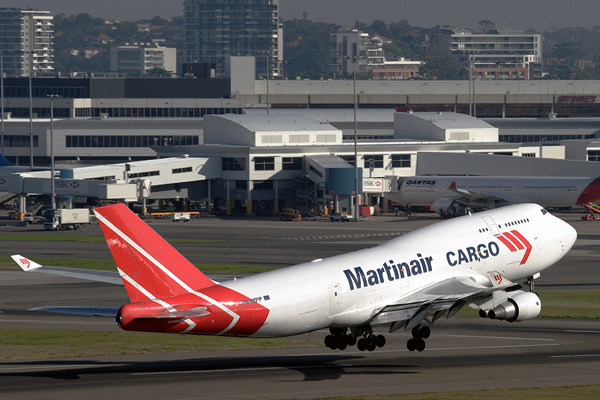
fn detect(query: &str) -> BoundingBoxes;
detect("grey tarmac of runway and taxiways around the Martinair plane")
[0,212,600,400]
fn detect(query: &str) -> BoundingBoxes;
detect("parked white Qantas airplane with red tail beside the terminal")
[386,176,600,216]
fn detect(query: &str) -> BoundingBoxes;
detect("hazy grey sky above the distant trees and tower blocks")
[0,0,600,32]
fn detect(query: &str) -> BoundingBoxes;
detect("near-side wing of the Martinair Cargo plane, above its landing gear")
[371,272,520,332]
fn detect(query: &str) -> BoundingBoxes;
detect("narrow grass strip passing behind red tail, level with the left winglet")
[0,256,282,274]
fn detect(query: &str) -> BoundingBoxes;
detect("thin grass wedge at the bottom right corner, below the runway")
[278,385,600,400]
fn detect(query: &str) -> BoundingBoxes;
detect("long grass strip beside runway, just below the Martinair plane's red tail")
[0,329,322,361]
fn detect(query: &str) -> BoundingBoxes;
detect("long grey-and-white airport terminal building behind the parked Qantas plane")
[0,68,600,212]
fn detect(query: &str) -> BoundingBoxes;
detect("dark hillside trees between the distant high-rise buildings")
[48,13,600,80]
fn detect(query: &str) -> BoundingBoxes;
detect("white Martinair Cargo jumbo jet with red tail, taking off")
[13,204,577,351]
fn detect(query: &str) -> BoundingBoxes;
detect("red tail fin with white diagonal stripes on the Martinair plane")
[95,204,215,302]
